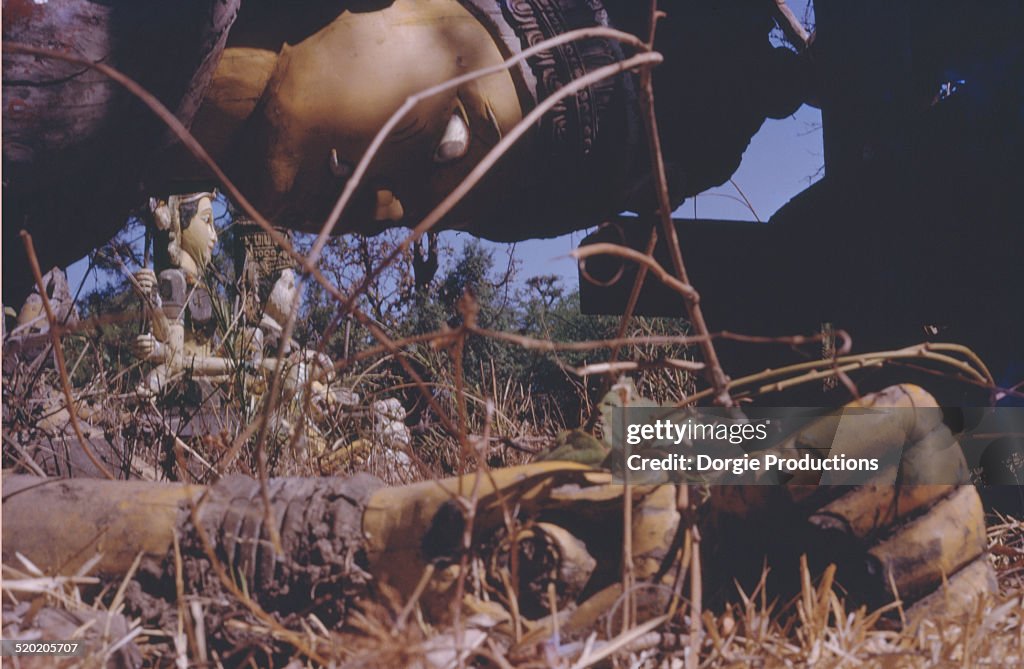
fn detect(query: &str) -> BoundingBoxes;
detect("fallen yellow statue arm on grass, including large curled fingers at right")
[3,387,994,643]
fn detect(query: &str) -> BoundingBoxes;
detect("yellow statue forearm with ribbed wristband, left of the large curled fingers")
[3,462,679,622]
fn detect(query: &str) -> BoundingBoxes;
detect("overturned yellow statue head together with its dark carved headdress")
[153,0,640,239]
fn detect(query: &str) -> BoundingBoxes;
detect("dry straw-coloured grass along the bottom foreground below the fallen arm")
[3,518,1024,669]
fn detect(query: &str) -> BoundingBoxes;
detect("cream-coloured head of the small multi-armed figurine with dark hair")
[150,193,217,279]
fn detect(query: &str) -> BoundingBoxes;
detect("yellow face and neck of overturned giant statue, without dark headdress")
[166,0,522,232]
